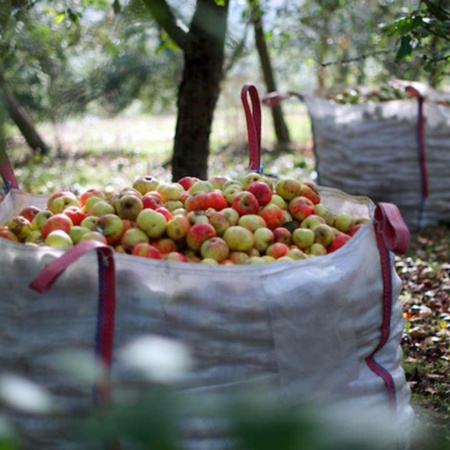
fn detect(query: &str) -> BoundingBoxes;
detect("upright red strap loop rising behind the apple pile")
[241,84,262,173]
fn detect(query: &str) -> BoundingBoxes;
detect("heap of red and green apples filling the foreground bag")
[0,172,368,264]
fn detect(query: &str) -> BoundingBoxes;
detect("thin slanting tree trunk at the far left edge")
[0,80,49,155]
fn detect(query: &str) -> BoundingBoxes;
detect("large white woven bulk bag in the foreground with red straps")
[0,188,413,450]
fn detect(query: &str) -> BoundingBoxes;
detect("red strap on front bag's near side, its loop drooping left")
[29,240,116,402]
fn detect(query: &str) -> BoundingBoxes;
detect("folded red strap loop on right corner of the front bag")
[374,202,410,255]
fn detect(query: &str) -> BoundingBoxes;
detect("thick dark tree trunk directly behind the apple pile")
[172,0,229,181]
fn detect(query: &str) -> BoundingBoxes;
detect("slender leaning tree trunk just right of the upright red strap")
[252,3,291,146]
